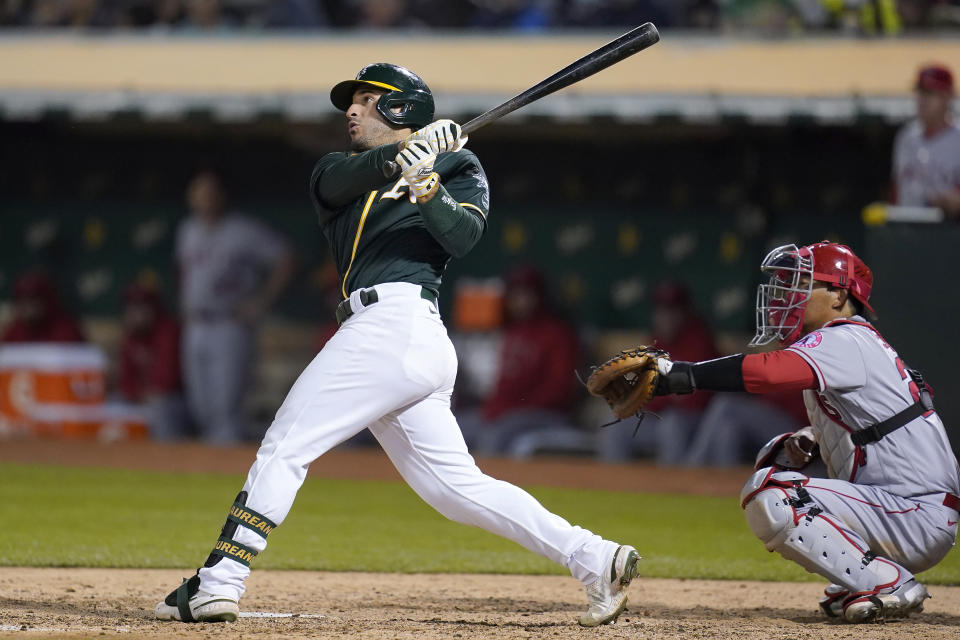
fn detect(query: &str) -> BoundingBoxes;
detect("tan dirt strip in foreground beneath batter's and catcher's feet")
[0,569,960,640]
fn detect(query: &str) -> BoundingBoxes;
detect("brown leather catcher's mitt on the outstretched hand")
[586,346,670,419]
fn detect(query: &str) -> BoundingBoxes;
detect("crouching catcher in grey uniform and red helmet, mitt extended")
[587,242,960,622]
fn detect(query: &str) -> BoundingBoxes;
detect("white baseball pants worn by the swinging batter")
[200,283,617,599]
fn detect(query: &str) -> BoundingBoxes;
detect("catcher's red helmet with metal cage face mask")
[750,241,876,346]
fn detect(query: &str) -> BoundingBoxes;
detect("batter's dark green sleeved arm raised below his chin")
[312,144,397,209]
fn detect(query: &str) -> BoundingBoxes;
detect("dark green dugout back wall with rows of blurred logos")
[0,203,861,333]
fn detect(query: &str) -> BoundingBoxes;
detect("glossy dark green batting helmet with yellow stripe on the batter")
[330,62,433,128]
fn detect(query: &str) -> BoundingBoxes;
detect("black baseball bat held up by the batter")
[382,22,660,178]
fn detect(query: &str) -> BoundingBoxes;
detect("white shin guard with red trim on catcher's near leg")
[742,468,912,594]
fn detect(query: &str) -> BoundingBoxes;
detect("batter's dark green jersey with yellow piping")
[310,144,490,298]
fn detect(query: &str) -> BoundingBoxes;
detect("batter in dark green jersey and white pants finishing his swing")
[156,63,639,626]
